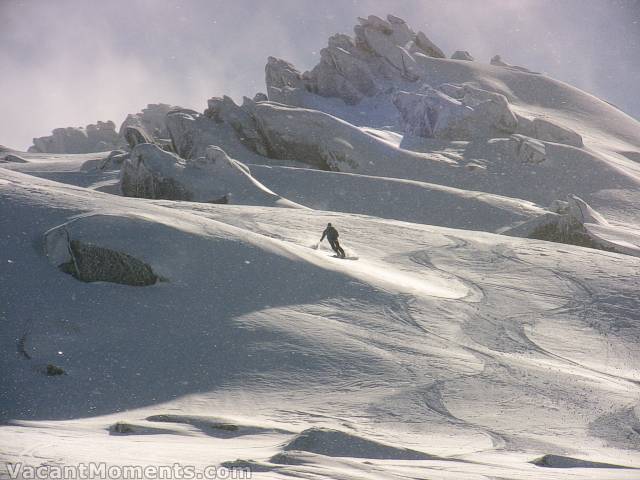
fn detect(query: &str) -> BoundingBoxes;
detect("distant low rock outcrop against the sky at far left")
[29,121,121,153]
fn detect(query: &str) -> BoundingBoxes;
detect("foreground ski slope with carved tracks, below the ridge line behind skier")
[0,169,640,478]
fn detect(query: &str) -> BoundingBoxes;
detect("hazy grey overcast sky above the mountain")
[0,0,640,149]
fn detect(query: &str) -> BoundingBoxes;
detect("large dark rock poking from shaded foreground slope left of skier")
[45,225,159,286]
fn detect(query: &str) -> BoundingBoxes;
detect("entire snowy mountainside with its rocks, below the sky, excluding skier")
[0,10,640,480]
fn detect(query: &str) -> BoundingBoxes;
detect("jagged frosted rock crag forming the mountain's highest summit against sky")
[266,15,445,106]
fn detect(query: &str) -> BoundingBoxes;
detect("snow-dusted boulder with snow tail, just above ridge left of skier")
[120,143,296,207]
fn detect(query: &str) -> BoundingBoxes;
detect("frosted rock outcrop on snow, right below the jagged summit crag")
[393,85,518,140]
